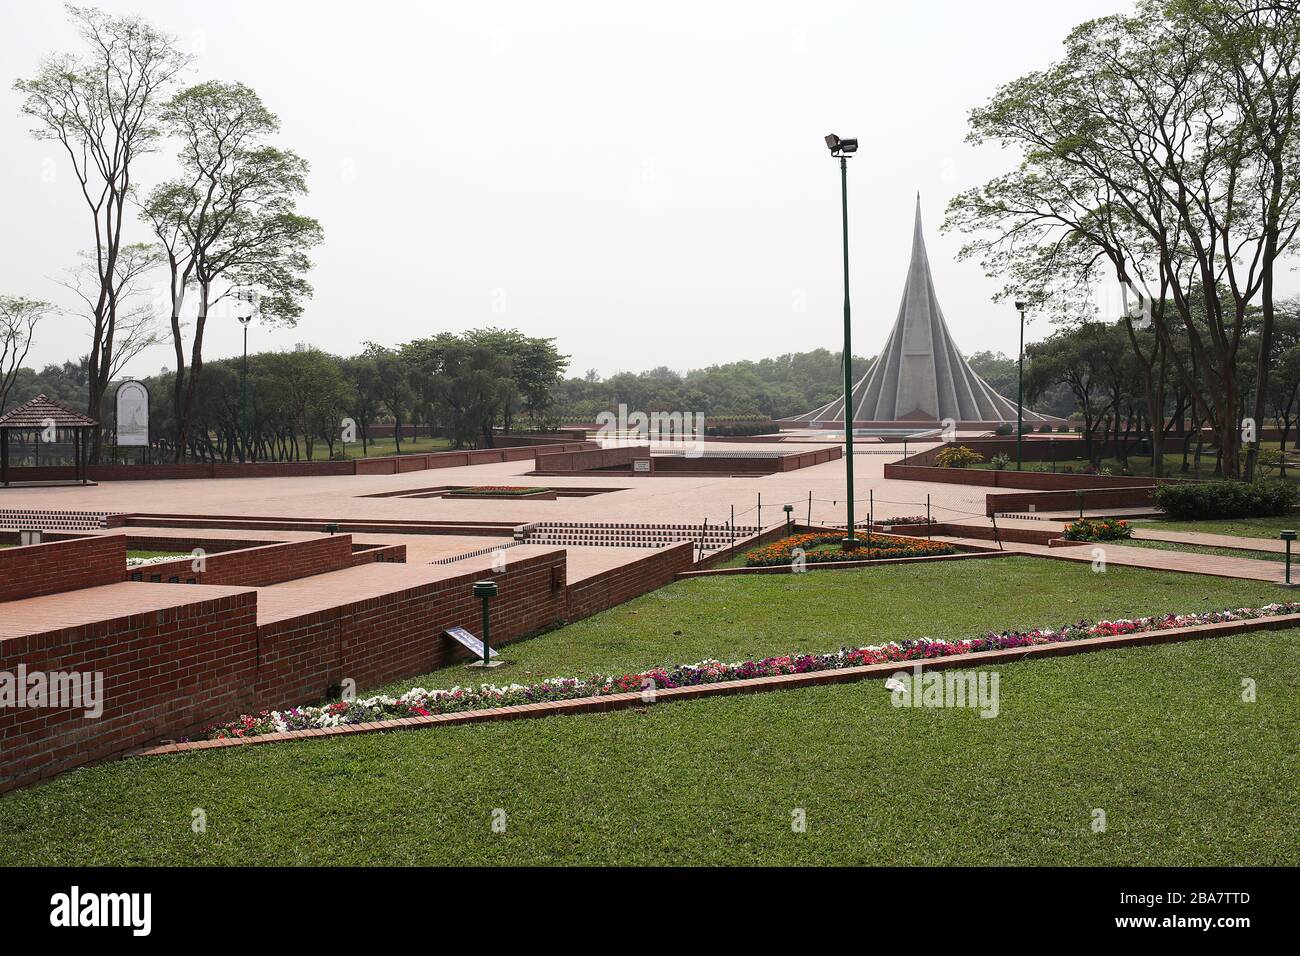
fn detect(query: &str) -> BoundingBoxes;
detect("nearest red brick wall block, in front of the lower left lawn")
[0,590,257,792]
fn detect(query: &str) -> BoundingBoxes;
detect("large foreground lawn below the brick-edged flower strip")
[0,629,1300,866]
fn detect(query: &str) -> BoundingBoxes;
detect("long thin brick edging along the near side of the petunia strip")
[125,614,1300,757]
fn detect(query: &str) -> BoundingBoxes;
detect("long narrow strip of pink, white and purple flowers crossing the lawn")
[205,604,1300,740]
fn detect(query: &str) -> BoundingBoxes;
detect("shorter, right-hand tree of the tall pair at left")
[144,82,322,457]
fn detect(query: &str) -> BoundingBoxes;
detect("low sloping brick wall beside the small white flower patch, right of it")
[126,535,354,588]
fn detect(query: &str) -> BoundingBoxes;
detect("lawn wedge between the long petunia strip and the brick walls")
[371,557,1291,697]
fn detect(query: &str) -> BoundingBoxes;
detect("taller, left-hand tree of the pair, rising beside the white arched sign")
[14,5,187,457]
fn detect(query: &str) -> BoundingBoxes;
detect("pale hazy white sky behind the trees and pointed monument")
[0,0,1126,375]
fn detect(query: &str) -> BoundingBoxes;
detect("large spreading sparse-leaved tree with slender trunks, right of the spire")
[949,0,1300,476]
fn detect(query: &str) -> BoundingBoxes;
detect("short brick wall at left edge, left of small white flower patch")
[0,535,126,601]
